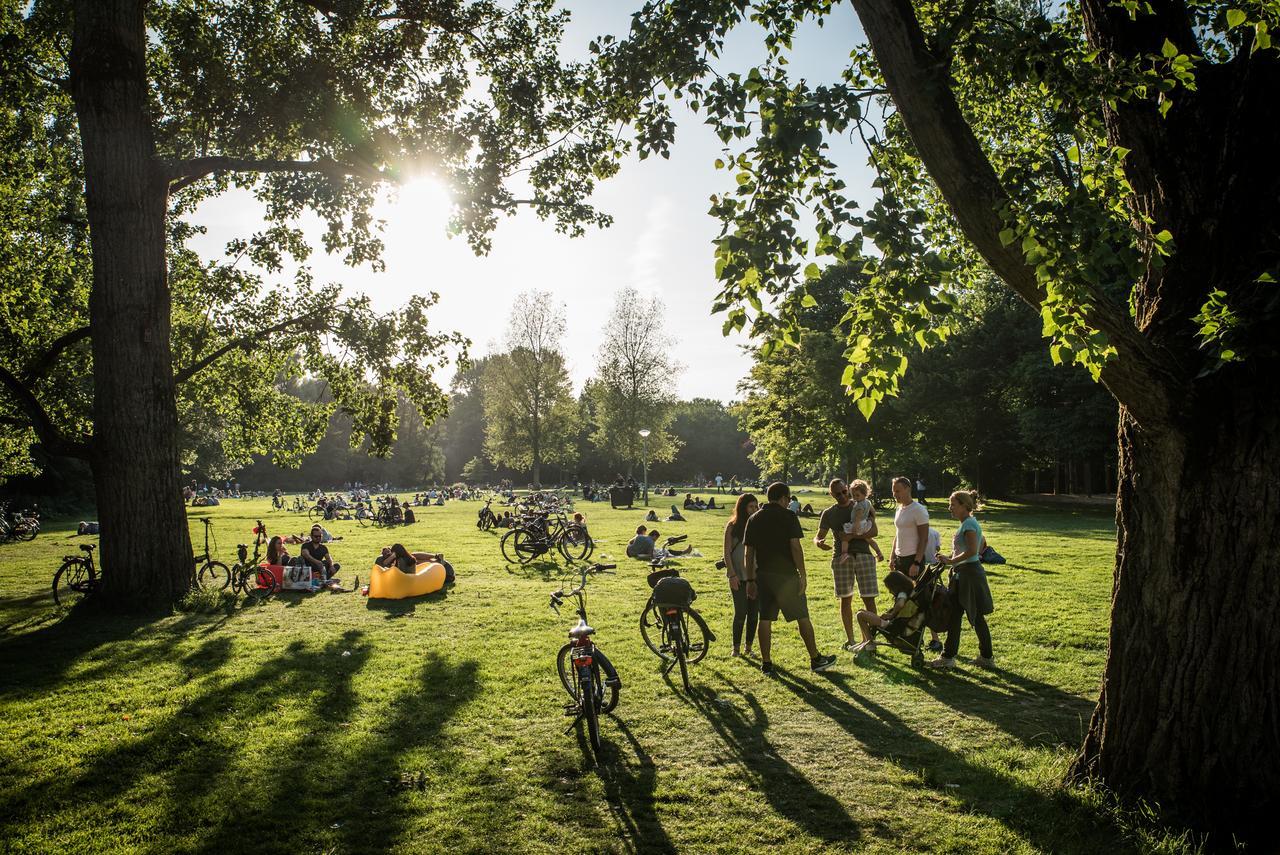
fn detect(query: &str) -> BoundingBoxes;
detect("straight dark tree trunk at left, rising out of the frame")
[72,0,193,611]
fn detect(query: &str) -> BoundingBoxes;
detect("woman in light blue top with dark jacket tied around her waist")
[929,490,996,668]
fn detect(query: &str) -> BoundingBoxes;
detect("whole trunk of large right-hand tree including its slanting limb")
[854,0,1280,843]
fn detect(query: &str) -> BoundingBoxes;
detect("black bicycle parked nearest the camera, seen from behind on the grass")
[550,564,622,756]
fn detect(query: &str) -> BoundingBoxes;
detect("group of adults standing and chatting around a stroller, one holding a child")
[724,477,995,673]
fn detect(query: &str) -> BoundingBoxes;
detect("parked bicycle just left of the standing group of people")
[640,535,716,691]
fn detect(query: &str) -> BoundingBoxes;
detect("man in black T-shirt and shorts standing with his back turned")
[742,481,836,673]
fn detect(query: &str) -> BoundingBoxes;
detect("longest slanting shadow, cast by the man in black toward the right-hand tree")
[774,667,1123,852]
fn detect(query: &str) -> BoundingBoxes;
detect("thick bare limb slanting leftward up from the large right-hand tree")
[854,0,1183,428]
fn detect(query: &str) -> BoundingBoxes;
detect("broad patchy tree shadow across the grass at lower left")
[6,630,477,852]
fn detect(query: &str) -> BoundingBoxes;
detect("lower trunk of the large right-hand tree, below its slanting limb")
[1074,383,1280,841]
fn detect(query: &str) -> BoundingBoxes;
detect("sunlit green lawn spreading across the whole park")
[0,497,1180,852]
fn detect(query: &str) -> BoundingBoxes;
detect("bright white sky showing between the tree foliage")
[192,0,872,402]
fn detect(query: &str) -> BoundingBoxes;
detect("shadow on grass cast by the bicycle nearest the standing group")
[678,677,861,845]
